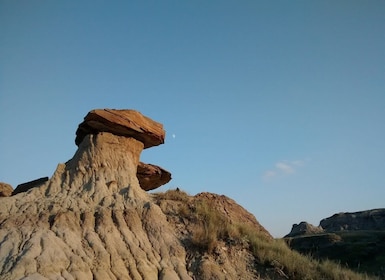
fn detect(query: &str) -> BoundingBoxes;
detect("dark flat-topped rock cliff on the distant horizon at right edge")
[320,208,385,232]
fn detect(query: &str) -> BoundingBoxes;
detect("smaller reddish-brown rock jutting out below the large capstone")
[136,162,171,191]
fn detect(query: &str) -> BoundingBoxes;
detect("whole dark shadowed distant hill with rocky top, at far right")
[285,209,385,279]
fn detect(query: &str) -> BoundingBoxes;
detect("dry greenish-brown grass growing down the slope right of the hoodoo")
[153,191,373,280]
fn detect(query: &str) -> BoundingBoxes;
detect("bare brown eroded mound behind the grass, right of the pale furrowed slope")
[154,189,274,280]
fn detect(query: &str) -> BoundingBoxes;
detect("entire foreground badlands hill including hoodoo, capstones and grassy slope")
[0,109,369,280]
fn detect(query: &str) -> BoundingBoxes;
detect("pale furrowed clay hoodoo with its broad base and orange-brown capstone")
[0,111,191,280]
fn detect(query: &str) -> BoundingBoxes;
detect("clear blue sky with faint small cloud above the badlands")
[0,0,385,237]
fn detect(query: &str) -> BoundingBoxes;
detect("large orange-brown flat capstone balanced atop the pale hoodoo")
[75,109,165,149]
